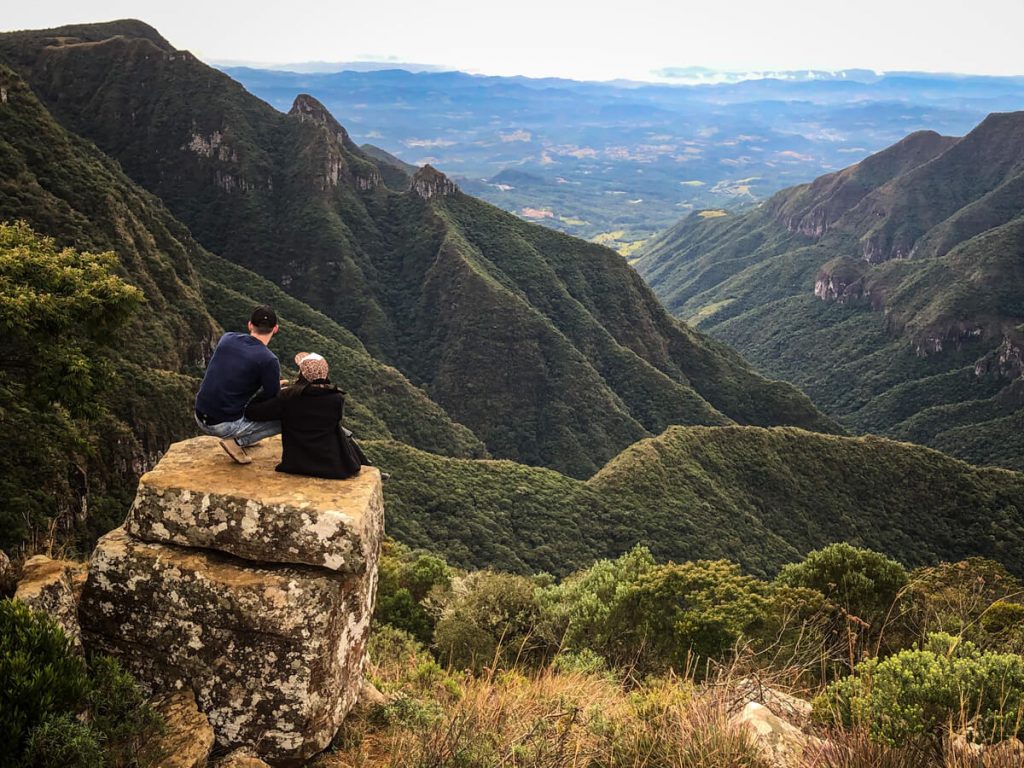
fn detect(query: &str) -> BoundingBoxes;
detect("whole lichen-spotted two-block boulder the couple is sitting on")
[79,437,383,765]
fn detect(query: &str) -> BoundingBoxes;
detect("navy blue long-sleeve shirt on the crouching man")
[196,333,281,423]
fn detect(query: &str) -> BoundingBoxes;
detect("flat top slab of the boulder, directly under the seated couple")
[126,437,384,573]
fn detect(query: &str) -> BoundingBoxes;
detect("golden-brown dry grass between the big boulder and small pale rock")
[318,643,768,768]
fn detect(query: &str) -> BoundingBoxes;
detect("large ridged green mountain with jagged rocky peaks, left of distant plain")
[0,22,836,477]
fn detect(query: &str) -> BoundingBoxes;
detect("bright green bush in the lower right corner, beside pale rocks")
[814,633,1024,745]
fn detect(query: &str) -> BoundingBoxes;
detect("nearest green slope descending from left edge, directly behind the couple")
[0,66,486,548]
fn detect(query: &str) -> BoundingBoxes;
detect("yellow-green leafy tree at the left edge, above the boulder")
[0,222,142,548]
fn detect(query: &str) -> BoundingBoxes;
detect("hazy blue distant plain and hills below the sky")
[225,68,1024,249]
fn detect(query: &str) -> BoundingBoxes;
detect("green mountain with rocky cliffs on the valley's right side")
[636,113,1024,469]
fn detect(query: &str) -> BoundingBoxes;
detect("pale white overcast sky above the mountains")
[8,0,1024,80]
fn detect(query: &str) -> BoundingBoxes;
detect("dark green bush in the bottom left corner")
[0,600,90,768]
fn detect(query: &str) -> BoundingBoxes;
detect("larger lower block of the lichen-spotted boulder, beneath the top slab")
[79,528,379,765]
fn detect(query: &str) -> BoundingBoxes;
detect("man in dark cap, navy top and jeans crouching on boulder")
[196,304,281,464]
